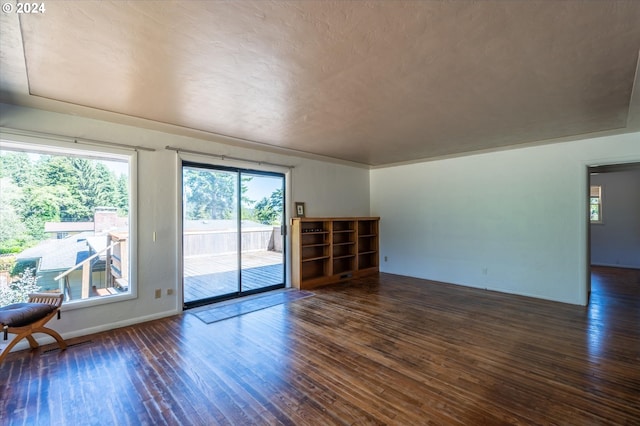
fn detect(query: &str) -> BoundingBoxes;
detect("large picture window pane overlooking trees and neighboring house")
[0,136,134,306]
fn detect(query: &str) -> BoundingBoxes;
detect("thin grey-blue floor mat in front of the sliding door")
[188,290,314,324]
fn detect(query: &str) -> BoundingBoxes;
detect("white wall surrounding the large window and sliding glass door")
[0,104,370,338]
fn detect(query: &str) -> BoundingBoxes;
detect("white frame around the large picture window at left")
[0,129,138,311]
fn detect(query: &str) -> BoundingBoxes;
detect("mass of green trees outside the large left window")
[0,151,129,252]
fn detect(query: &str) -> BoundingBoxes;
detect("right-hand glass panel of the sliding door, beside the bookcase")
[240,172,284,293]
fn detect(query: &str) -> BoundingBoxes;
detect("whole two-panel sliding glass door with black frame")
[182,162,285,308]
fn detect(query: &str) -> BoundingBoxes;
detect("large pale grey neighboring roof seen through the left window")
[16,232,106,272]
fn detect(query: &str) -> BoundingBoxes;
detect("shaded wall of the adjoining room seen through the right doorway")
[591,168,640,268]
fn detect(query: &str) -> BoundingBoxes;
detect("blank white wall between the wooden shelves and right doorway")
[371,133,640,305]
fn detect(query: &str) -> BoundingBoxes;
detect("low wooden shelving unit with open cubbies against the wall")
[291,217,380,289]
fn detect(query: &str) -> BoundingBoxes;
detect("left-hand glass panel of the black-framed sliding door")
[182,166,240,305]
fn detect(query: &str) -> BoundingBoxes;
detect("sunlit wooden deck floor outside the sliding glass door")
[184,250,284,302]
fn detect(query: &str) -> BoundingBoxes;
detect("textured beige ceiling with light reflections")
[0,0,640,165]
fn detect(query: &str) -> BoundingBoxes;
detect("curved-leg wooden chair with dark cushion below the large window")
[0,293,67,363]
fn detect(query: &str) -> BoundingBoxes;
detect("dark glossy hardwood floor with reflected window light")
[0,268,640,425]
